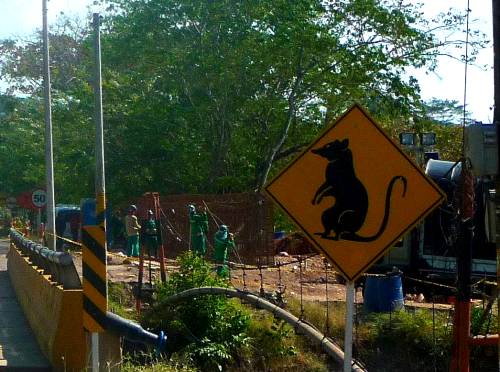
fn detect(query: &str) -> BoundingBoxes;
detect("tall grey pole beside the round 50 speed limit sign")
[42,0,56,250]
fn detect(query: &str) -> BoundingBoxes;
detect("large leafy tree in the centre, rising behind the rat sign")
[101,0,484,191]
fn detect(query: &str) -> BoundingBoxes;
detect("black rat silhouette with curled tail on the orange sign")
[311,138,407,242]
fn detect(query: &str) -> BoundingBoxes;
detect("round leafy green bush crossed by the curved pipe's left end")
[144,252,250,371]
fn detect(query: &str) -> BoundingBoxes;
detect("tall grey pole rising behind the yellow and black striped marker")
[92,13,107,372]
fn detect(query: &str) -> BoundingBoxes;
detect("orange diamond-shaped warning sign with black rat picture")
[265,105,445,280]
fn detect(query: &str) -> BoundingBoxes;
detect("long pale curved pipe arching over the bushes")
[159,287,366,372]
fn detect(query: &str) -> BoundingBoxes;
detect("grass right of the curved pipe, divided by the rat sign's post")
[288,299,452,371]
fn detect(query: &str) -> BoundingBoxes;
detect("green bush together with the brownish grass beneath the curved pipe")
[142,252,327,371]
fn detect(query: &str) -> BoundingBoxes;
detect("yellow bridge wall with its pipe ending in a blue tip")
[7,229,167,371]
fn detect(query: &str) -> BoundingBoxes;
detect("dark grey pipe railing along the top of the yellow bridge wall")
[10,229,82,289]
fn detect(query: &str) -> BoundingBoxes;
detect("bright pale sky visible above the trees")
[0,0,493,123]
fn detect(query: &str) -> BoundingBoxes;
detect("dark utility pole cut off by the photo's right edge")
[492,0,500,371]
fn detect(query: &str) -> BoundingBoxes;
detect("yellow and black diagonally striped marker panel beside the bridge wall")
[82,226,108,332]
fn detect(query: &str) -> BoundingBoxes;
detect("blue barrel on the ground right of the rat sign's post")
[363,273,404,313]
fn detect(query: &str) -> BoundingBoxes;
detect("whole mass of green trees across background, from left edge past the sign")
[0,0,483,205]
